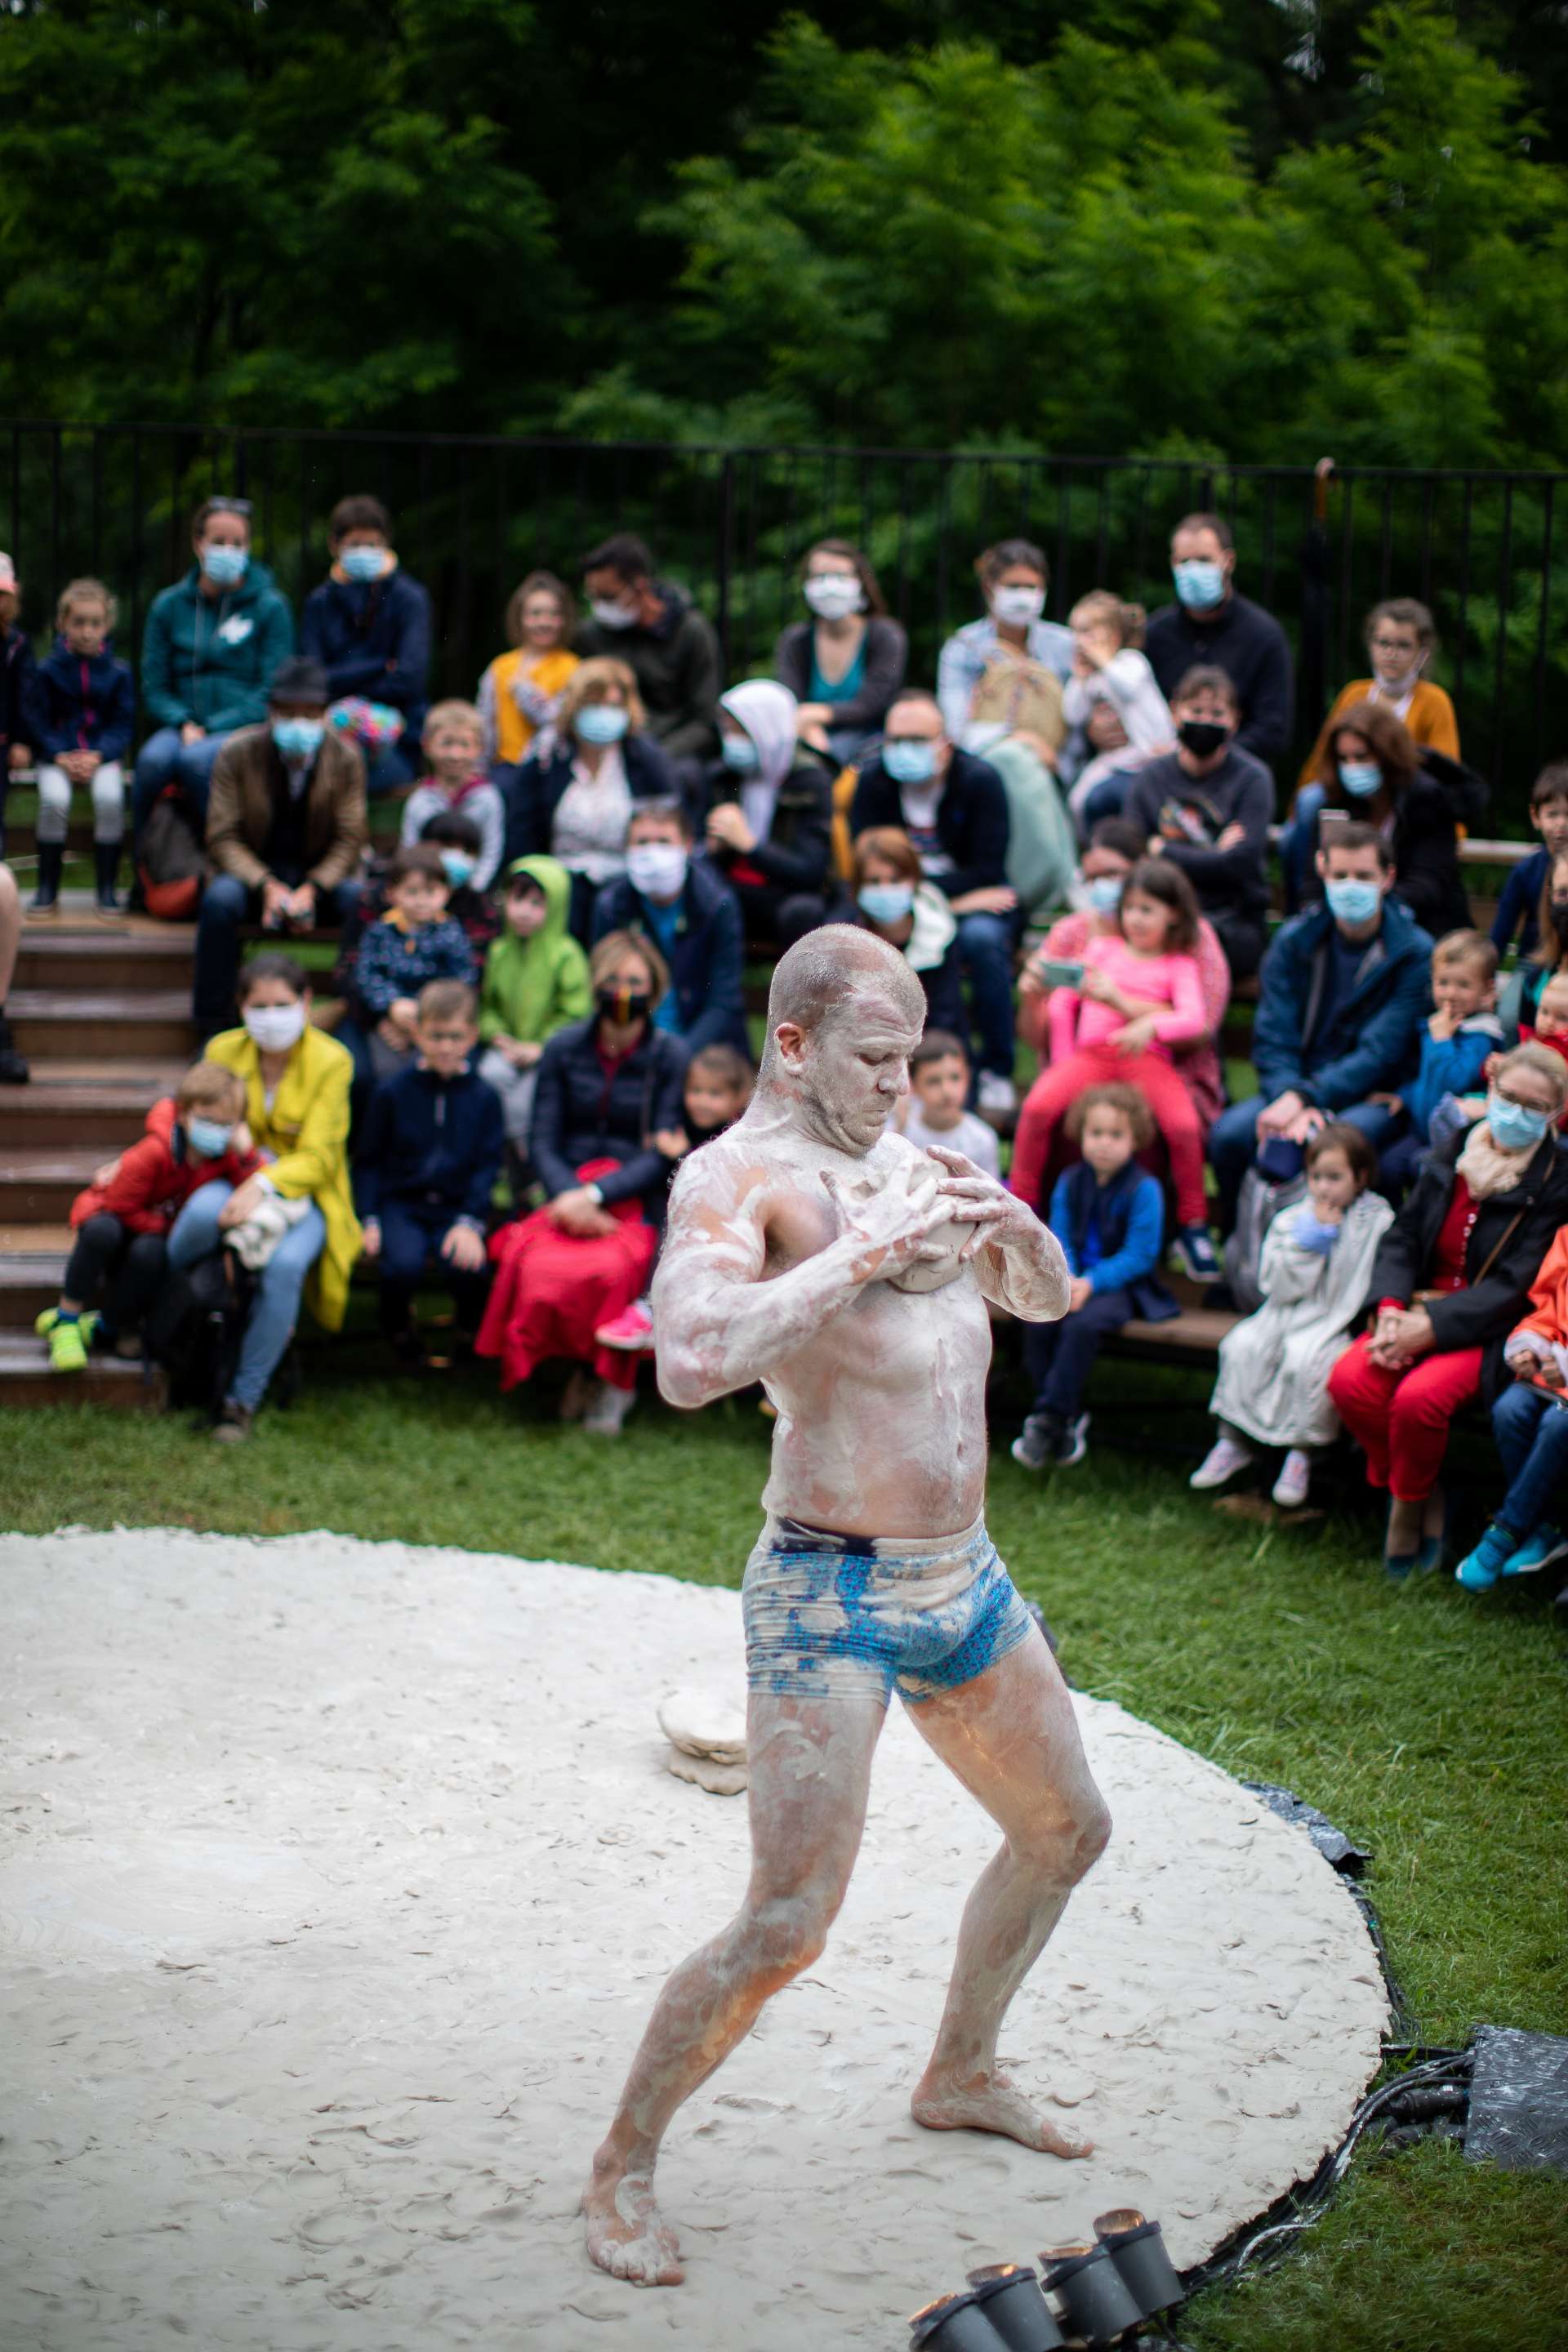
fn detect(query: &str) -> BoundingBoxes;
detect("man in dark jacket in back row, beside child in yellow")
[571,532,724,791]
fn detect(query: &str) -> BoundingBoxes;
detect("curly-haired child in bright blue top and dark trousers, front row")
[1013,1082,1178,1470]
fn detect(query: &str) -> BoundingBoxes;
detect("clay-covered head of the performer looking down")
[760,922,926,1160]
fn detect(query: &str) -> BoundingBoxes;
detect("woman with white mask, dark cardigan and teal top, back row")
[773,539,910,762]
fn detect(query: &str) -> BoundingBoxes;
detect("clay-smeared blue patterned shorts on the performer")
[741,1517,1035,1708]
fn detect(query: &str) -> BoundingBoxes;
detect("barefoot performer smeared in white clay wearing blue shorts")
[583,924,1110,2286]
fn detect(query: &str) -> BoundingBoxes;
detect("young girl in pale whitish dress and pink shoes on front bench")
[1187,1120,1394,1510]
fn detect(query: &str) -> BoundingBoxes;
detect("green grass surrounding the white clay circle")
[0,1341,1568,2352]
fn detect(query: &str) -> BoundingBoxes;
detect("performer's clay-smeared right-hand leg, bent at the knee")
[910,1639,1110,2157]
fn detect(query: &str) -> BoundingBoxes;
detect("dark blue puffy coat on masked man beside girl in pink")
[1253,898,1432,1115]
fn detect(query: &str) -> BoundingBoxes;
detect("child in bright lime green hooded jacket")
[479,856,592,1150]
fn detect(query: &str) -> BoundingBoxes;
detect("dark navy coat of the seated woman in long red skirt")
[529,1013,687,1202]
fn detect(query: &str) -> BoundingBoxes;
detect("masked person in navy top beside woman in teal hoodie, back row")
[299,494,430,797]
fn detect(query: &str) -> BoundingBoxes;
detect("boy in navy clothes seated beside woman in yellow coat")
[355,981,501,1362]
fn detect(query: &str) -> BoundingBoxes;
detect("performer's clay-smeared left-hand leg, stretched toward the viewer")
[583,1691,884,2286]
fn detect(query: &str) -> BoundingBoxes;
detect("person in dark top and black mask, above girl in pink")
[1121,668,1274,981]
